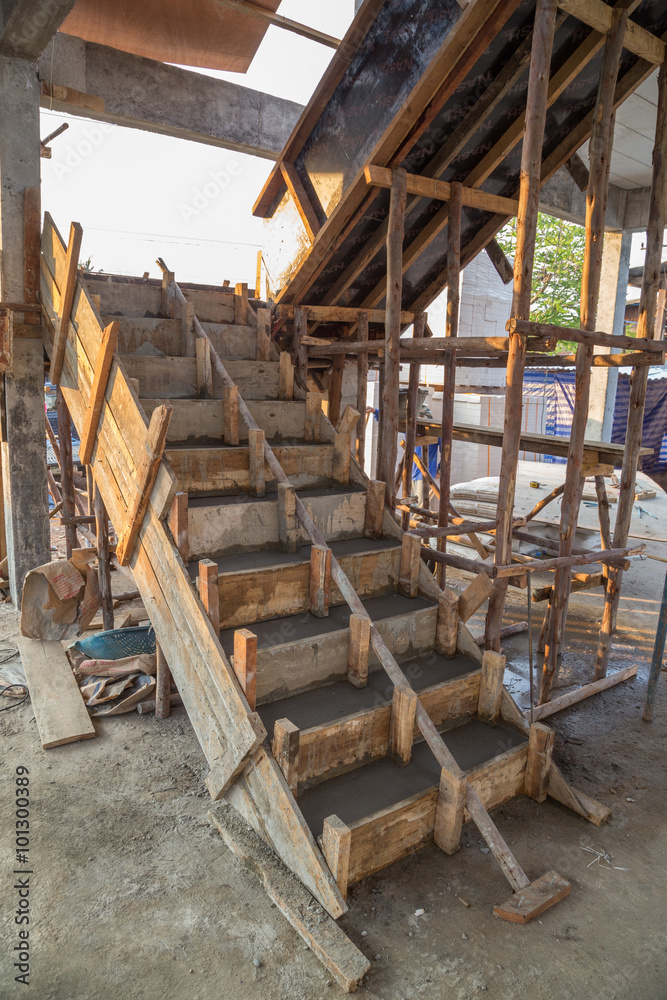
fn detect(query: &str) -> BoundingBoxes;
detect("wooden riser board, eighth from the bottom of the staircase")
[121,354,278,400]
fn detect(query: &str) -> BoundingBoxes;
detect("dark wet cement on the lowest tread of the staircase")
[298,719,526,836]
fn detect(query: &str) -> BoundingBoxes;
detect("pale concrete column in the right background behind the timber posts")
[586,232,632,441]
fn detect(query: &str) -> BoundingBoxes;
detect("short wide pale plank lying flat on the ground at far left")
[16,637,97,750]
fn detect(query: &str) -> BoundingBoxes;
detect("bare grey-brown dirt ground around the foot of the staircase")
[0,548,667,1000]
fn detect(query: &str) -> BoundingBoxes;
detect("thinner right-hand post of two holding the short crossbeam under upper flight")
[438,183,462,590]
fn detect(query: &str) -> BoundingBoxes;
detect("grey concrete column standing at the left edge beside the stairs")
[0,56,51,605]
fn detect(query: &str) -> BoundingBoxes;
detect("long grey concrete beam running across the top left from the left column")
[39,33,303,160]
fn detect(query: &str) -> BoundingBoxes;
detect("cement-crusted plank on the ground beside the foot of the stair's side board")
[208,807,370,993]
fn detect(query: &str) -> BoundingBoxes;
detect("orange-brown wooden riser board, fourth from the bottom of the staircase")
[190,538,401,628]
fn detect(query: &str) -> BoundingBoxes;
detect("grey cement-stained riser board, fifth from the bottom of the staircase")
[188,493,366,559]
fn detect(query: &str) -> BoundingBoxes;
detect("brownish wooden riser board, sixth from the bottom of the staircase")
[167,444,333,493]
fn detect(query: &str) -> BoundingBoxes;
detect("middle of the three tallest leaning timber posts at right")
[540,10,628,705]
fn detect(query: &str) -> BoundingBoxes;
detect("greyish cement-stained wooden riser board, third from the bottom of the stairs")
[256,608,437,704]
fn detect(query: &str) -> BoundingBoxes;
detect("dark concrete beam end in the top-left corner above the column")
[0,0,76,59]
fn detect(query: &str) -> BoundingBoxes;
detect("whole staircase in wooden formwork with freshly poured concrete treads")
[42,216,609,981]
